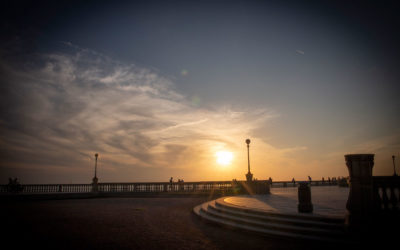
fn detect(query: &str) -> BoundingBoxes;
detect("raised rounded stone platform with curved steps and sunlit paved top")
[193,186,348,242]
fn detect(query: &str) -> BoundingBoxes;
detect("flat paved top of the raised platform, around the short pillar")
[224,186,349,218]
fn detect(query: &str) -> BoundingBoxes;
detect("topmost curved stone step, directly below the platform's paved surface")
[208,202,344,232]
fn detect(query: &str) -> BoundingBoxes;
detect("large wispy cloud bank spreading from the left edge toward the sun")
[0,44,274,182]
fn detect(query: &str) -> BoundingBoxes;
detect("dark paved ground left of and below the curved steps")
[0,198,354,249]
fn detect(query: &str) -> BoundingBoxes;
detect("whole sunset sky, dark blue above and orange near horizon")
[0,0,400,184]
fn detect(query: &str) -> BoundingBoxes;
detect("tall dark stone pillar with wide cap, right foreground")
[344,154,374,228]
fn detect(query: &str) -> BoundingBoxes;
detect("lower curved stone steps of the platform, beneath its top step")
[193,201,346,242]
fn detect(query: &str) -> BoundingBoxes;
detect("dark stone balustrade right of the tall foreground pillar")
[372,176,400,213]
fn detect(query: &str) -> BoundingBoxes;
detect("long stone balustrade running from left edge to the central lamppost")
[0,181,268,194]
